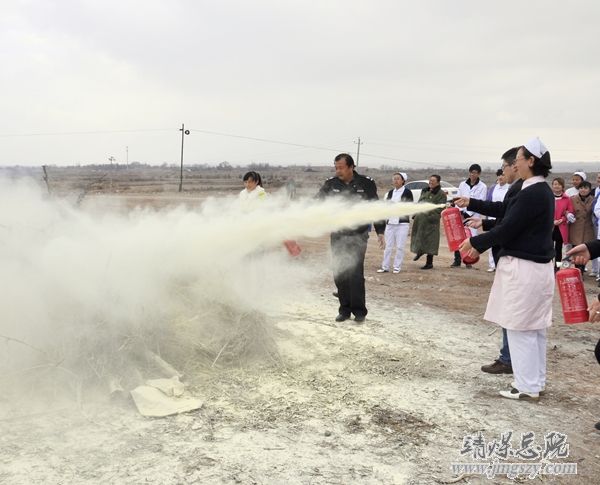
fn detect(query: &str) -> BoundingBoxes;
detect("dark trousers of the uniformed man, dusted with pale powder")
[331,232,369,317]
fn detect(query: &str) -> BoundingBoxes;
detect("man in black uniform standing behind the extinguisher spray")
[317,153,385,322]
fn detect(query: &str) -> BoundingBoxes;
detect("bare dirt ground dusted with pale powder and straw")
[0,186,600,484]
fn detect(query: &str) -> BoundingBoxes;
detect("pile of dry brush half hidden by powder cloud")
[0,302,280,401]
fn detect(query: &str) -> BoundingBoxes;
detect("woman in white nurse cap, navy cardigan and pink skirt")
[460,138,554,401]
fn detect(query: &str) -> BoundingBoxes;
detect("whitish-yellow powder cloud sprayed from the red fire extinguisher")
[0,180,431,400]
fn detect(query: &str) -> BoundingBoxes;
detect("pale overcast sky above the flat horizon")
[0,0,600,167]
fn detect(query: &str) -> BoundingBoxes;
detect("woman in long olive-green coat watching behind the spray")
[410,175,446,269]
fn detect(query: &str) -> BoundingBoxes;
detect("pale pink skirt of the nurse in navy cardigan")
[483,256,554,330]
